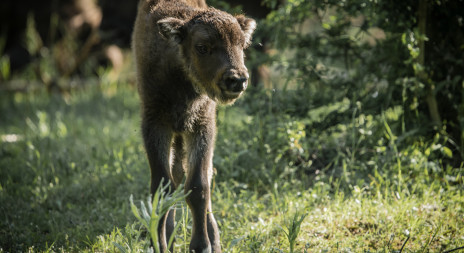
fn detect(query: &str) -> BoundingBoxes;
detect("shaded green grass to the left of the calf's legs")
[0,85,149,252]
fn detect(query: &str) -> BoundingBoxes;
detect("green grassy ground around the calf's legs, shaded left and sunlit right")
[0,84,464,252]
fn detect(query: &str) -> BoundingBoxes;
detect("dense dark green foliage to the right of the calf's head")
[254,0,464,166]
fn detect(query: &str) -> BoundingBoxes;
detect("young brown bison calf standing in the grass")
[133,0,256,253]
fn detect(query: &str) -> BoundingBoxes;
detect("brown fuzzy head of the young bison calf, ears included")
[158,8,256,104]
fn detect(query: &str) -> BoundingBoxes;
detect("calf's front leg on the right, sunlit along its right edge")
[185,124,221,253]
